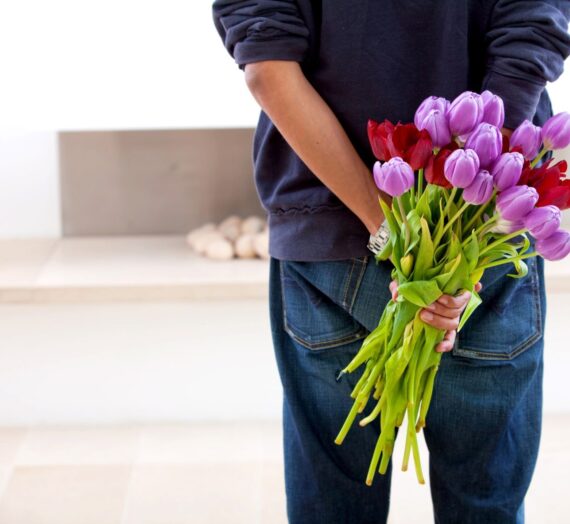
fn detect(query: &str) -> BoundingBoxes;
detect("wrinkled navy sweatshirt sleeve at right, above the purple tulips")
[482,0,570,128]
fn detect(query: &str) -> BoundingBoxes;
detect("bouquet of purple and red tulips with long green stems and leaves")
[335,91,570,485]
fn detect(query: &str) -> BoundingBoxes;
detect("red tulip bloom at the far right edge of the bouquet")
[518,160,570,209]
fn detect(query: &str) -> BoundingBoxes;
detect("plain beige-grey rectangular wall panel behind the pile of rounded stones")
[59,129,263,236]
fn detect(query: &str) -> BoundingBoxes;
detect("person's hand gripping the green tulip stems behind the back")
[390,280,483,353]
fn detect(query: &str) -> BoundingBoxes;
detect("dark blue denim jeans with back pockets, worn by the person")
[270,256,546,524]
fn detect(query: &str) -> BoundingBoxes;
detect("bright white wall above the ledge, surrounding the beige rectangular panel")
[0,0,570,237]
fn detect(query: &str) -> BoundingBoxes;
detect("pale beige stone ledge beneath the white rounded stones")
[0,236,570,303]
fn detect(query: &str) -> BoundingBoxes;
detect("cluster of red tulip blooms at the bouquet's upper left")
[368,120,433,170]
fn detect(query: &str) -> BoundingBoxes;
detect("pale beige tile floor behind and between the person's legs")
[0,415,570,524]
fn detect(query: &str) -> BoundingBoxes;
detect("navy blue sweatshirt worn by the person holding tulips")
[213,0,570,261]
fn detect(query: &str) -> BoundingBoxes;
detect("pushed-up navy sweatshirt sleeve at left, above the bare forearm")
[212,0,309,69]
